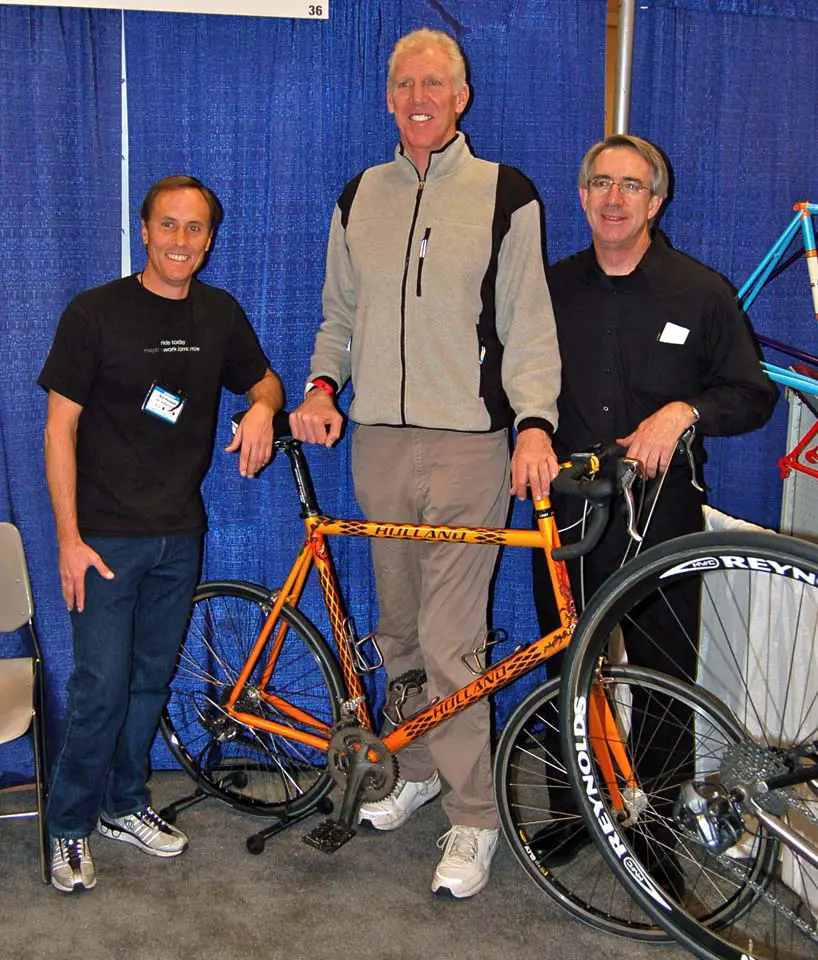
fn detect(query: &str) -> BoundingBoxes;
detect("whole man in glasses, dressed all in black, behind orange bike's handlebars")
[534,135,778,888]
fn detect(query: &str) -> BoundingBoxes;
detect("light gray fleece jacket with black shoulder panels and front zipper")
[310,133,560,432]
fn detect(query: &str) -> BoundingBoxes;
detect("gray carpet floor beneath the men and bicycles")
[0,773,689,960]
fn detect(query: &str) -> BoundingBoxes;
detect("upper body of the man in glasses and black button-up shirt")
[548,136,777,476]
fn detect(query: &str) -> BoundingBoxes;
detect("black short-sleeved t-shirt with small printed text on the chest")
[38,276,268,536]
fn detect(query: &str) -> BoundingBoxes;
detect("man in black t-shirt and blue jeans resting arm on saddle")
[38,176,284,893]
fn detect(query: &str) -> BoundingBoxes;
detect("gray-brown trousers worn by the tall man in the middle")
[352,425,509,827]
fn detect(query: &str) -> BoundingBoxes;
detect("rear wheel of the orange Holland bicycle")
[160,581,344,817]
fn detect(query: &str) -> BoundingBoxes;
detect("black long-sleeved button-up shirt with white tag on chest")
[548,236,778,460]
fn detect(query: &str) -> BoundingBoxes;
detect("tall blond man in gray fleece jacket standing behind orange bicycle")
[292,30,560,897]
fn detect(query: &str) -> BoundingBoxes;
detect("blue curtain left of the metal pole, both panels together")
[0,0,605,772]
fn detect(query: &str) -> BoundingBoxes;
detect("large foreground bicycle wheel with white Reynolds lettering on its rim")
[560,532,818,960]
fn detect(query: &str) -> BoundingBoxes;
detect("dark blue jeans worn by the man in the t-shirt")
[46,533,202,837]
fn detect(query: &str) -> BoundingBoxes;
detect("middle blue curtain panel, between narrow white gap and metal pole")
[125,0,605,744]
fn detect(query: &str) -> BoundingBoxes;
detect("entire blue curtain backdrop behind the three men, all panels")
[0,0,818,770]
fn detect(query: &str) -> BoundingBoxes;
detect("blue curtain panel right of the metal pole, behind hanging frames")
[631,0,818,527]
